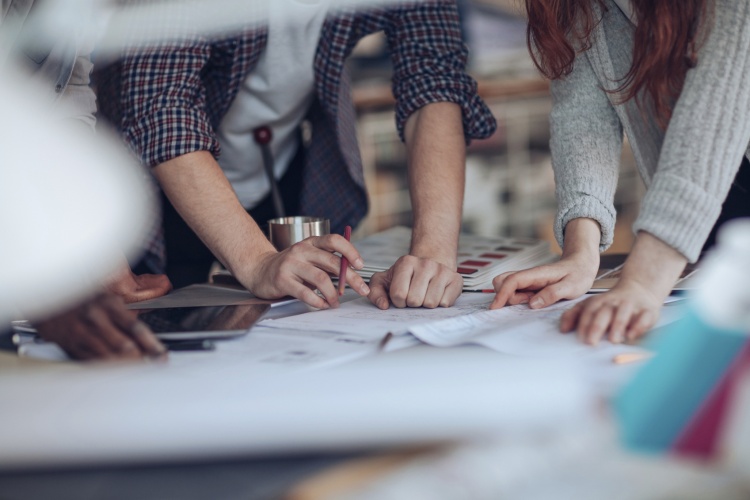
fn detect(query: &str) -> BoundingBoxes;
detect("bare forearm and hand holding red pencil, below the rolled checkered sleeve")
[154,151,369,308]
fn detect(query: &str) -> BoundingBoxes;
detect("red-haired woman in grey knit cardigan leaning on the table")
[491,0,750,344]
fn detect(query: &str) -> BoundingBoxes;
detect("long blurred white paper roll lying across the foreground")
[0,348,596,469]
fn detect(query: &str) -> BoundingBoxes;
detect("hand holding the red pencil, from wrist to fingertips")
[241,234,370,309]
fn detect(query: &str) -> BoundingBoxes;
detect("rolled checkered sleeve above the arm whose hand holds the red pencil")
[119,37,219,167]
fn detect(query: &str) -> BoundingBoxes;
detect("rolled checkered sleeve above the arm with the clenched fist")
[385,0,497,142]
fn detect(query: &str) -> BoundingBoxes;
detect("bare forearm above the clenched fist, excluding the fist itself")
[405,102,466,268]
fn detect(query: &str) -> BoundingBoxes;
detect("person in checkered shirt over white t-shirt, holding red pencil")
[99,0,495,309]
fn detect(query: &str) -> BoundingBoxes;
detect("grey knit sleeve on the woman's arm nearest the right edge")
[633,0,750,262]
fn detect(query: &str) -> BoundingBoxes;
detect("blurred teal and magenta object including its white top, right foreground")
[614,219,750,458]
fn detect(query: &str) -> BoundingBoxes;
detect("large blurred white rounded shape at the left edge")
[0,67,154,323]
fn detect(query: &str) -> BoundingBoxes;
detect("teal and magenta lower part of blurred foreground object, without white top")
[615,311,750,457]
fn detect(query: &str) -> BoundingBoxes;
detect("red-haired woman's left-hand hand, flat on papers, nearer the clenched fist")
[490,254,599,309]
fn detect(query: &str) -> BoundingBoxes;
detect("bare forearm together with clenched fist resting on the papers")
[370,102,466,309]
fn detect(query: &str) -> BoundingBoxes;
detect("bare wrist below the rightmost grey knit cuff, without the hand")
[621,231,687,300]
